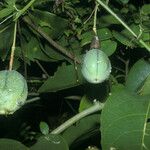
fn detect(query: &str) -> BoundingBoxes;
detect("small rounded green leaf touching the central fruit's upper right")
[101,40,117,56]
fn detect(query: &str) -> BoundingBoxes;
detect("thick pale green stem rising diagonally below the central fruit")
[51,102,104,134]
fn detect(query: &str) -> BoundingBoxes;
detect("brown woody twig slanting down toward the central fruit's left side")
[23,17,81,64]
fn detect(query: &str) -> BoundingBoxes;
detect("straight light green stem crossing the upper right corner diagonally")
[97,0,150,52]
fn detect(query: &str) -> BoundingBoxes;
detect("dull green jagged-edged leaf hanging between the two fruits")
[38,64,84,92]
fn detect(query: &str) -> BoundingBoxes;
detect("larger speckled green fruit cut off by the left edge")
[0,70,28,114]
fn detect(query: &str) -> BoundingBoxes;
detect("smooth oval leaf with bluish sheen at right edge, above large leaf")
[126,59,150,92]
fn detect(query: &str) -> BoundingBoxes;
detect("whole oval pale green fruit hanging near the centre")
[81,49,111,84]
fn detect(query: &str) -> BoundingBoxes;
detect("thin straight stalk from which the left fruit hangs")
[9,21,17,70]
